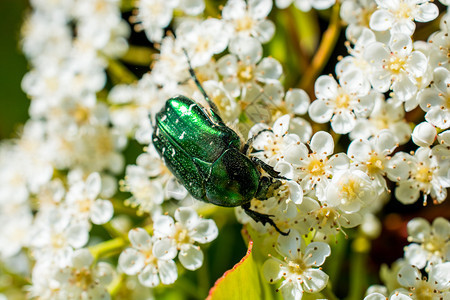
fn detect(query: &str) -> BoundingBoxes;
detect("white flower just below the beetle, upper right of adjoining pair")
[154,207,219,271]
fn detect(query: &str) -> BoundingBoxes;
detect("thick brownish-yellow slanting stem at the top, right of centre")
[298,4,341,95]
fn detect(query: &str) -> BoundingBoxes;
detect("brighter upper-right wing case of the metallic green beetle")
[155,96,241,163]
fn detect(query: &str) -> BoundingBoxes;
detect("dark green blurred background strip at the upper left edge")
[0,0,29,140]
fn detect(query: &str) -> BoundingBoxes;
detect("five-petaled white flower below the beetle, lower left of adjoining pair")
[119,228,178,287]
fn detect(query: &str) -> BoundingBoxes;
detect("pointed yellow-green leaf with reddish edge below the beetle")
[207,241,272,300]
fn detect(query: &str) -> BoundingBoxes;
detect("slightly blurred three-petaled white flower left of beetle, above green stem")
[66,173,114,224]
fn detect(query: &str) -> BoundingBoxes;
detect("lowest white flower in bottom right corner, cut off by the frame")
[397,262,450,299]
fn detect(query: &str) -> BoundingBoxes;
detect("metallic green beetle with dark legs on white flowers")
[152,52,289,235]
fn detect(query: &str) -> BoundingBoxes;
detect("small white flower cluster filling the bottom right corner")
[364,218,450,300]
